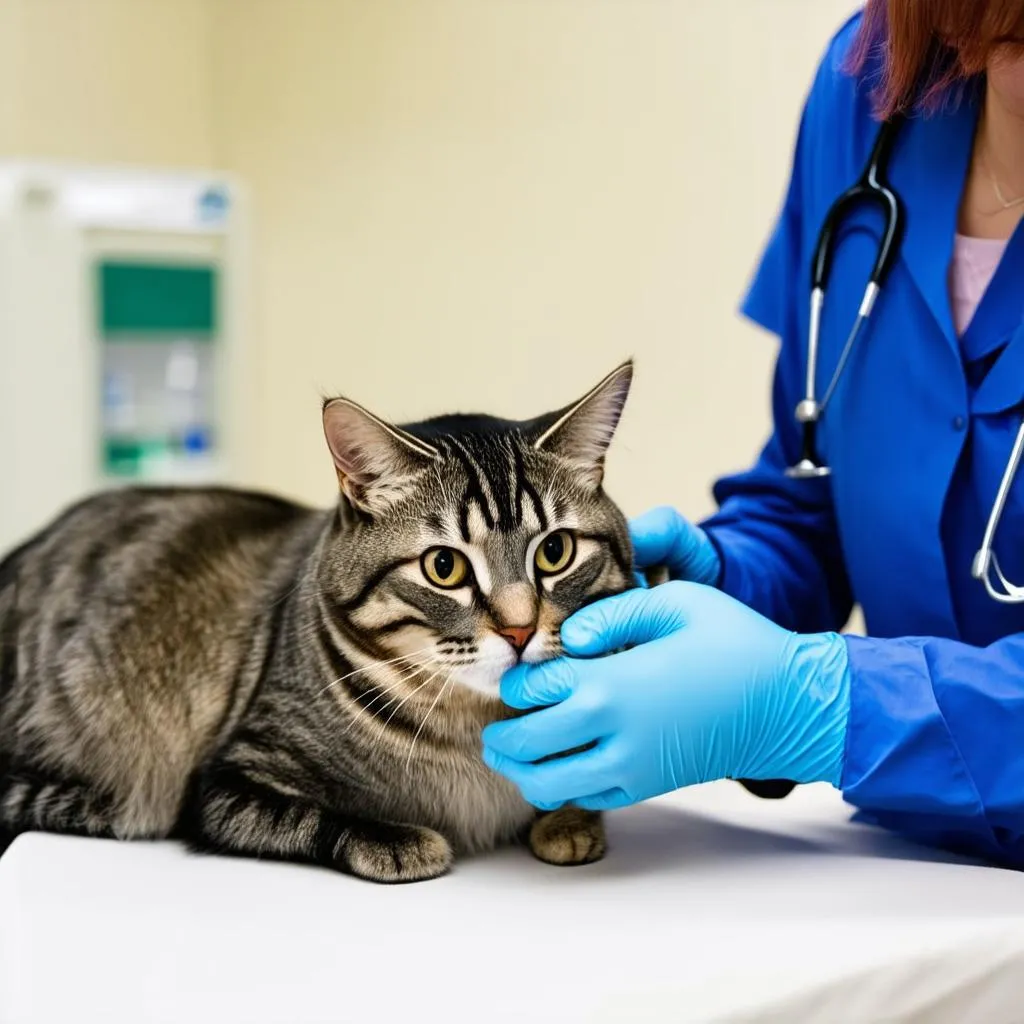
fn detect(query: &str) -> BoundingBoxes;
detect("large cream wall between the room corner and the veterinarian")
[213,0,853,514]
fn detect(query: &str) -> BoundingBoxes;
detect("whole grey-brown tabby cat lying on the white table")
[0,362,635,883]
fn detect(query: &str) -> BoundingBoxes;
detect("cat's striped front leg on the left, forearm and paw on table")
[182,768,453,884]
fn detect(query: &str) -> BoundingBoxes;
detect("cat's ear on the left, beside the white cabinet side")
[324,398,437,514]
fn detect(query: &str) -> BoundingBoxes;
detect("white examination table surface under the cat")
[0,783,1024,1024]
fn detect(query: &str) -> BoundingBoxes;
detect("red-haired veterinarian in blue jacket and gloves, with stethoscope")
[483,0,1024,867]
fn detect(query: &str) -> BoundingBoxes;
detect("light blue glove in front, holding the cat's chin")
[483,583,850,810]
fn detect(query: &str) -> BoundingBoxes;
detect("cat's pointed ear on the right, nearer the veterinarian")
[534,359,633,487]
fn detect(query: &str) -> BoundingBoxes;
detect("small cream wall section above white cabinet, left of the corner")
[0,0,217,167]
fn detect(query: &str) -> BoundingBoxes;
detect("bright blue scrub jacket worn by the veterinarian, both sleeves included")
[703,15,1024,868]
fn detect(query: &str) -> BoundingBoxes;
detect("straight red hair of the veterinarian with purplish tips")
[848,0,1024,118]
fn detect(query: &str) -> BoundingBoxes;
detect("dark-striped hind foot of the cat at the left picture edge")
[0,767,115,841]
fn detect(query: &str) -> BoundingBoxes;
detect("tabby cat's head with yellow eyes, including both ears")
[319,362,635,697]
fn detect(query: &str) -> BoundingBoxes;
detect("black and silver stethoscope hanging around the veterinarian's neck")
[785,116,1024,604]
